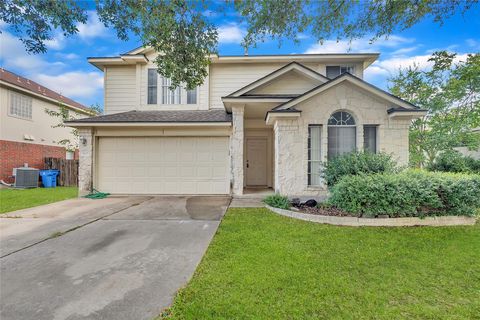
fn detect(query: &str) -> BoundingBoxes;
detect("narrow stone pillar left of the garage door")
[78,128,93,196]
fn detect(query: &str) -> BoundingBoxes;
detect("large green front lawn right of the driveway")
[164,208,480,319]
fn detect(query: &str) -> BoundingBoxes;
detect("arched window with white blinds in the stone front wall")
[327,111,357,160]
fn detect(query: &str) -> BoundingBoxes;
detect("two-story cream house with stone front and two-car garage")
[66,48,425,196]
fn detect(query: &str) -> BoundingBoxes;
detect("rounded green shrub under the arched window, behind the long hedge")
[323,152,396,187]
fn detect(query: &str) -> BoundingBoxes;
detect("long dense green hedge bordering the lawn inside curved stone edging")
[329,170,480,217]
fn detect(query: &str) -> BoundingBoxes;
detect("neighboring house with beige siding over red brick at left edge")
[0,68,95,182]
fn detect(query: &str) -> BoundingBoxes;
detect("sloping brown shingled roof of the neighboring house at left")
[0,68,93,113]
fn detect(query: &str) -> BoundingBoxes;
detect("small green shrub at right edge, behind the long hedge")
[428,150,480,173]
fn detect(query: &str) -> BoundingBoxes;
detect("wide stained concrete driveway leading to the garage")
[0,197,230,320]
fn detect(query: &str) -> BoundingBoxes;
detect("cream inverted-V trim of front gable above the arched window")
[276,74,415,110]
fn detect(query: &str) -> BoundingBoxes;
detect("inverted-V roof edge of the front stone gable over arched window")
[272,73,419,111]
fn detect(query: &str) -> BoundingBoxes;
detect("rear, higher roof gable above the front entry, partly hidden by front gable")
[227,62,329,97]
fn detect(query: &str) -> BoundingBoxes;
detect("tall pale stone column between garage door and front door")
[230,106,245,195]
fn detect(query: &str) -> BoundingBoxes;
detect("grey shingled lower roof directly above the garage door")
[66,109,232,124]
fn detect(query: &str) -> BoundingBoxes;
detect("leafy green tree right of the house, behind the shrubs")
[390,51,480,166]
